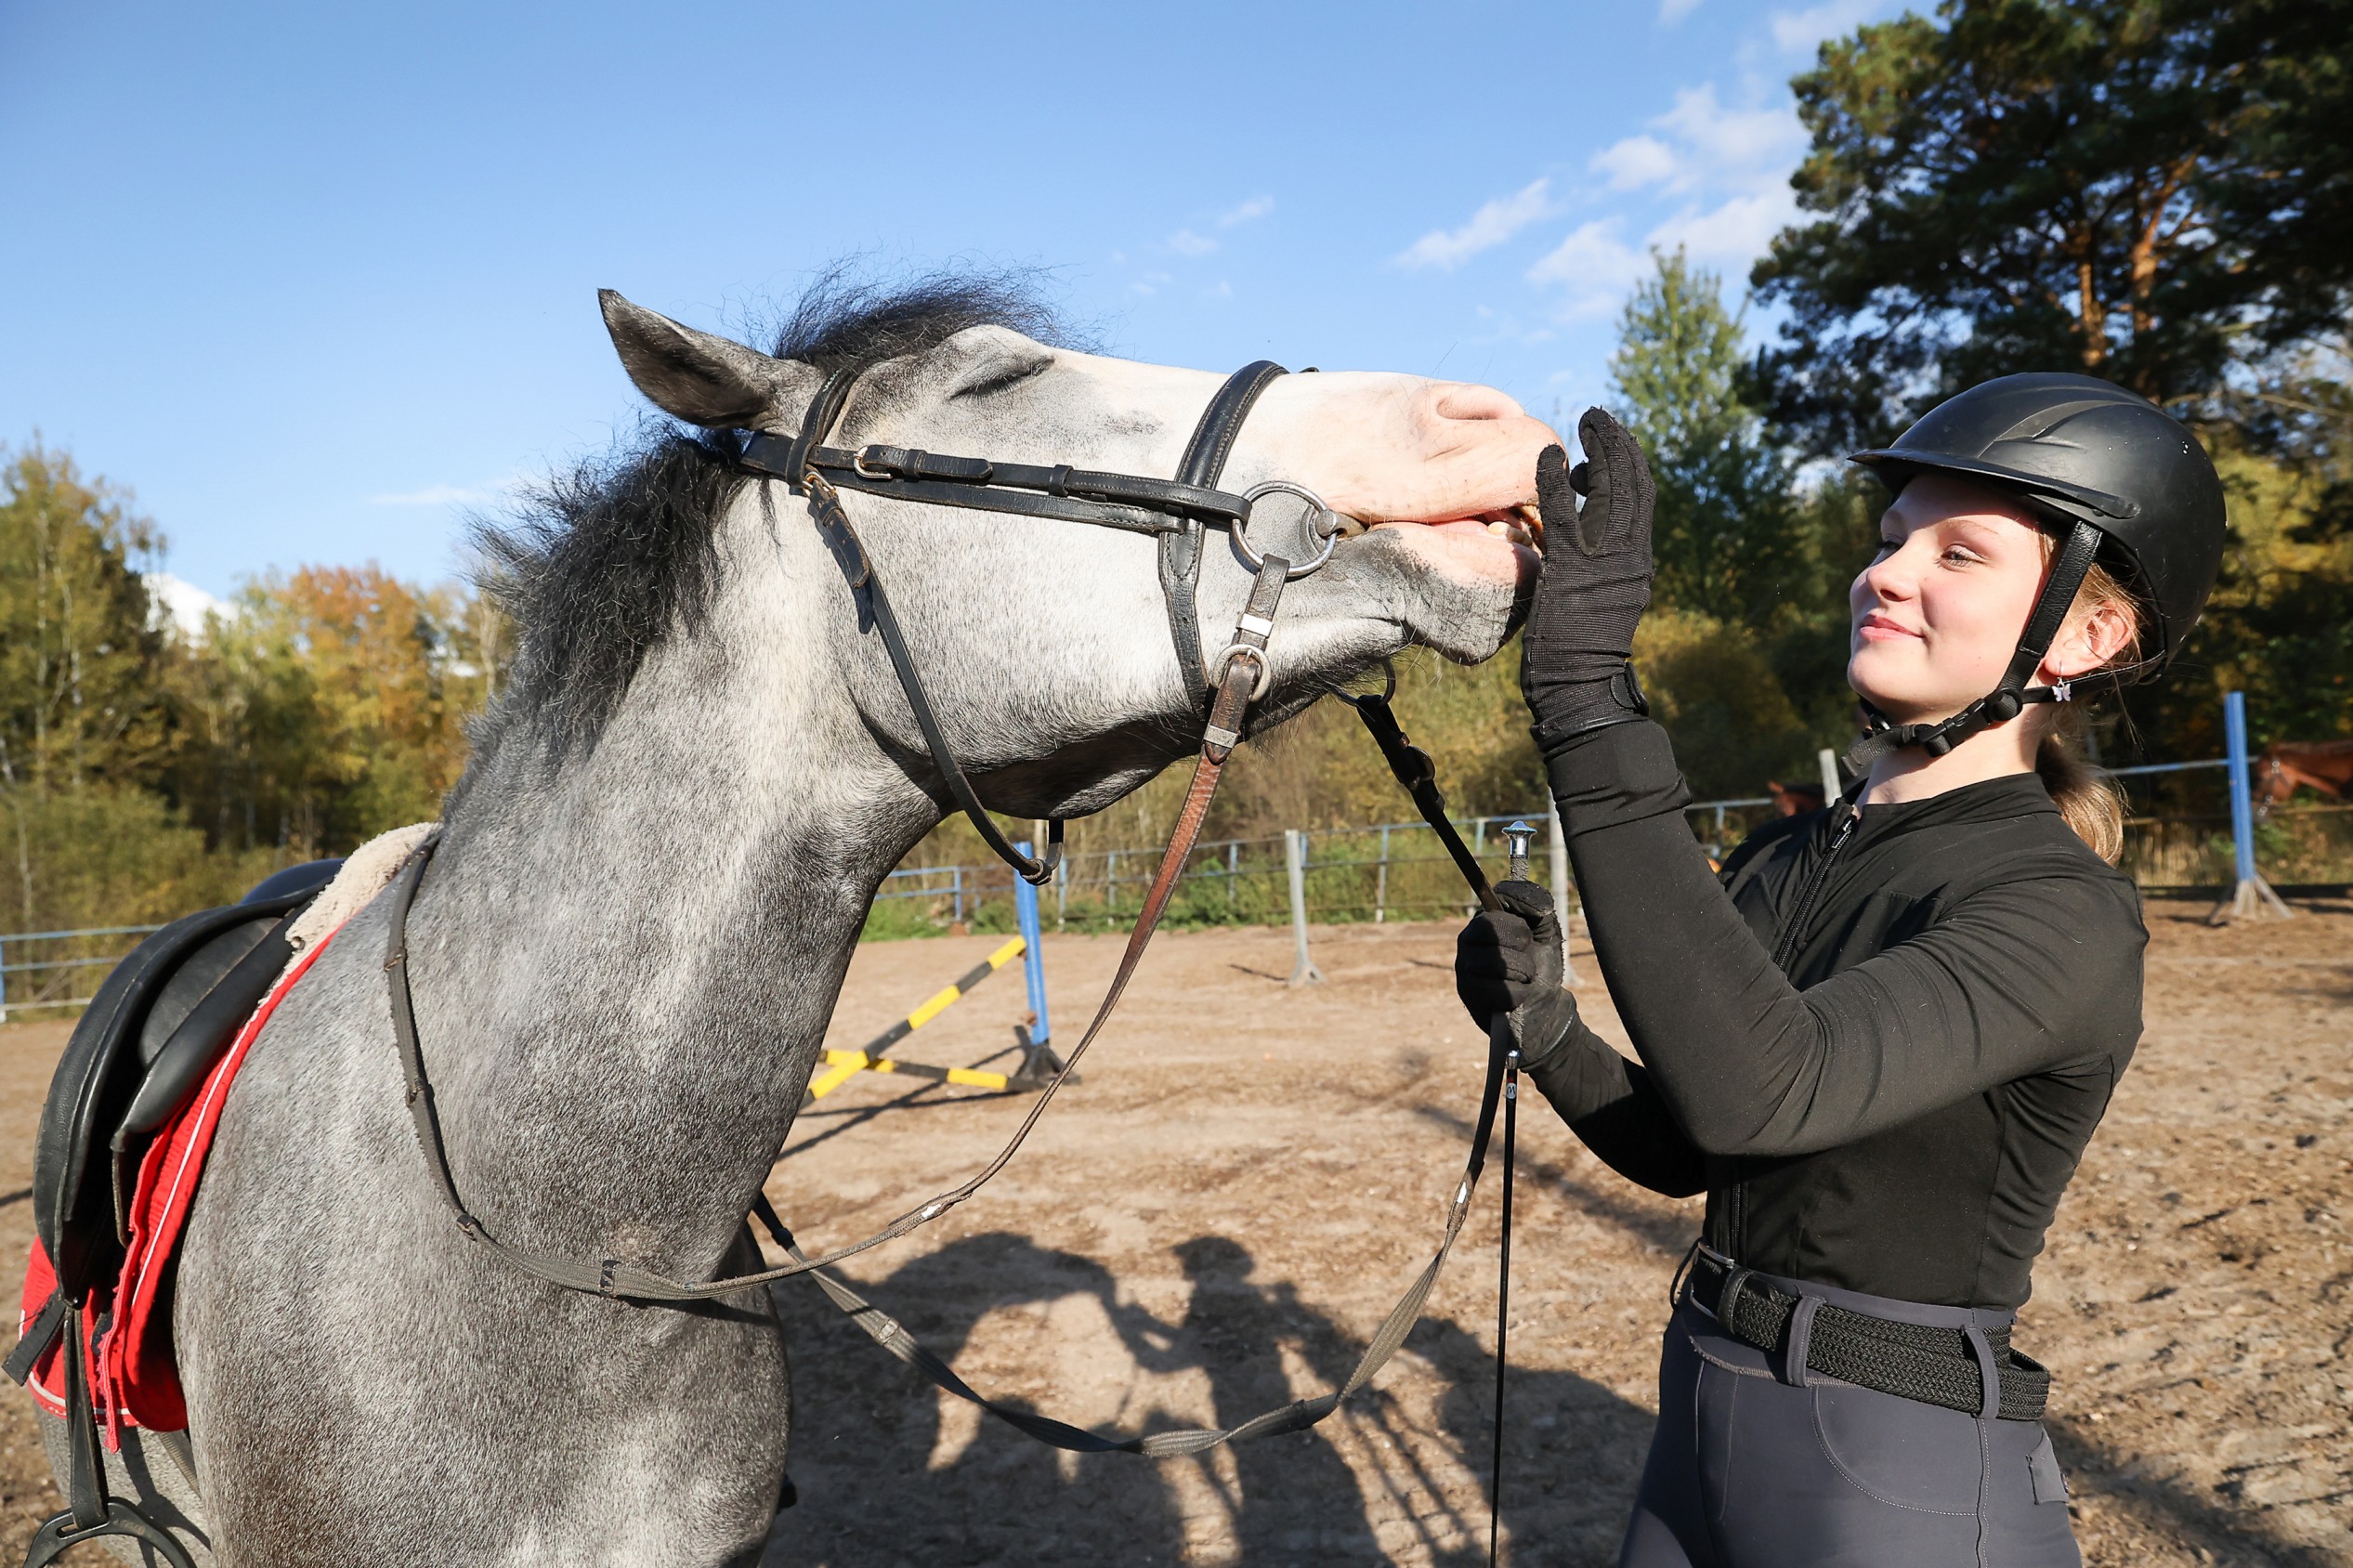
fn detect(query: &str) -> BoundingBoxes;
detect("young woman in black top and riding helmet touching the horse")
[1457,374,2224,1568]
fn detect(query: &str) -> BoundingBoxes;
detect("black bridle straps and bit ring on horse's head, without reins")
[743,360,1339,882]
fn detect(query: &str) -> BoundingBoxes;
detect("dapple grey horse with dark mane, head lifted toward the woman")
[47,282,1553,1568]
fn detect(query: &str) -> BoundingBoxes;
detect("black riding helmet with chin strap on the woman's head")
[1847,372,2226,765]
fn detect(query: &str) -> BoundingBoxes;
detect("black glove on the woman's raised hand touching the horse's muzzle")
[1520,407,1654,751]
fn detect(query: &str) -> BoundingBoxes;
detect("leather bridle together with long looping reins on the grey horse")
[384,360,1510,1457]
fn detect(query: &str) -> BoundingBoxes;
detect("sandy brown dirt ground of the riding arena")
[0,902,2353,1568]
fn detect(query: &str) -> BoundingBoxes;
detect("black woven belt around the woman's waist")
[1685,1252,2052,1422]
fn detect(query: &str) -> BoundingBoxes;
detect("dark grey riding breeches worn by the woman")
[1619,1274,2083,1568]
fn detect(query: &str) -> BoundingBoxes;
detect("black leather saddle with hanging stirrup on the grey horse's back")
[7,859,344,1568]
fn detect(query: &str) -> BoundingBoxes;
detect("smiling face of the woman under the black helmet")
[1847,473,2047,723]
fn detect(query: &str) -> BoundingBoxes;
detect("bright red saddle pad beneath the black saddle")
[17,933,332,1448]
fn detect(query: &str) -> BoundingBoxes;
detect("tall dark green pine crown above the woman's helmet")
[1753,0,2353,454]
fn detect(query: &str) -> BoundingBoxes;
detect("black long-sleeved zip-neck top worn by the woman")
[1529,723,2149,1307]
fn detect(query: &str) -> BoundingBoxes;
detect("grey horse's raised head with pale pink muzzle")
[588,283,1553,815]
